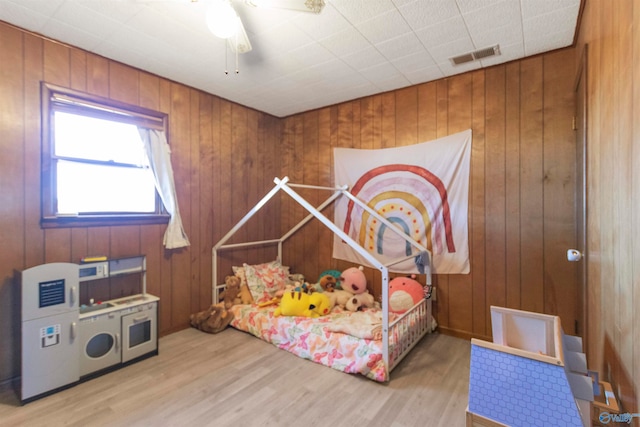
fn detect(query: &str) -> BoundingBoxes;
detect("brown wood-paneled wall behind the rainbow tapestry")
[282,49,579,337]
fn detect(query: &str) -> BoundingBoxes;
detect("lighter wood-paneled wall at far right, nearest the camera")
[576,0,640,413]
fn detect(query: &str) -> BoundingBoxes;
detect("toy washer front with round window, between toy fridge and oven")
[79,312,121,377]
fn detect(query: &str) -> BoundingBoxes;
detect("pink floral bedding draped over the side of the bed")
[231,305,388,382]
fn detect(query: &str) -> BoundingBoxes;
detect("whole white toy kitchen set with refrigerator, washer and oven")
[20,256,159,404]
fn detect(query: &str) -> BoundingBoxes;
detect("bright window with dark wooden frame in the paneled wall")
[42,83,169,231]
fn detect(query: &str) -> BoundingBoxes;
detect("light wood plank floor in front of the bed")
[0,328,470,427]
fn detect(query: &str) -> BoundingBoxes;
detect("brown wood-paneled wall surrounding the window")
[0,23,281,381]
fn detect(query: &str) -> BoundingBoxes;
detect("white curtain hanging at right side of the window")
[138,128,190,249]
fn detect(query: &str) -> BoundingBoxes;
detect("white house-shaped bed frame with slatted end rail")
[212,177,432,379]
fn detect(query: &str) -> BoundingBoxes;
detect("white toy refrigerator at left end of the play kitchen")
[21,263,80,403]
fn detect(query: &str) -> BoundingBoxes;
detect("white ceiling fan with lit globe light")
[204,0,326,53]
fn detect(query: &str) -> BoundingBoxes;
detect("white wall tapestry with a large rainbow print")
[333,129,471,274]
